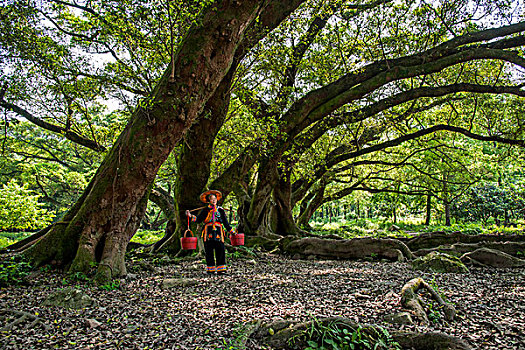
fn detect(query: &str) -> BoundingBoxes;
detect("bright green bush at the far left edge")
[0,180,55,230]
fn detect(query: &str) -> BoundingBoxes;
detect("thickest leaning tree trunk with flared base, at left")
[20,0,262,281]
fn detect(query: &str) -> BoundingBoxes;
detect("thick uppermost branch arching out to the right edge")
[281,22,525,135]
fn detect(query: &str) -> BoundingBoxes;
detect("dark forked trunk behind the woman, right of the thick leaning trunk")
[150,0,304,251]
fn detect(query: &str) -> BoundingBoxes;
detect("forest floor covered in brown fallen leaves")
[0,254,525,350]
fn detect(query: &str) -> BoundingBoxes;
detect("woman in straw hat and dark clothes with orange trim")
[186,190,233,275]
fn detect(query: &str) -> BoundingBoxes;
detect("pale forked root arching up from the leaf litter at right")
[401,277,456,323]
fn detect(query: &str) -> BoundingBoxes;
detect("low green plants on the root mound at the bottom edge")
[290,318,401,350]
